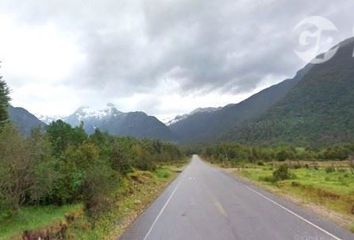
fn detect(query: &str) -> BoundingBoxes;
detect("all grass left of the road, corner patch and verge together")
[0,165,182,240]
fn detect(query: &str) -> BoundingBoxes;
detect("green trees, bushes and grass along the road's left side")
[0,78,183,239]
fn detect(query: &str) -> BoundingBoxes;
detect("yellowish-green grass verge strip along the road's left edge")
[67,166,179,240]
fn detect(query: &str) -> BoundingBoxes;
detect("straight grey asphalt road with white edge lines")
[120,156,354,240]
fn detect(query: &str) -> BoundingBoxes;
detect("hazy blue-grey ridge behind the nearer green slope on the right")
[169,65,311,143]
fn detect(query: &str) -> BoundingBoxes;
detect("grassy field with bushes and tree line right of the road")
[203,144,354,231]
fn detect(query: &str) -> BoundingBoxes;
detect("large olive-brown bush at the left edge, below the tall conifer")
[0,124,55,216]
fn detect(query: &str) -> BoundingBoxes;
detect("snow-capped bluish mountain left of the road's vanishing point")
[63,104,173,140]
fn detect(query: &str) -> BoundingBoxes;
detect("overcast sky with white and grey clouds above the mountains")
[0,0,354,120]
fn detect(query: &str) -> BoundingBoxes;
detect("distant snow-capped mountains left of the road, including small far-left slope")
[9,104,175,141]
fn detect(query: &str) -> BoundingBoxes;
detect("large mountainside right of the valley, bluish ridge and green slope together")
[170,38,354,145]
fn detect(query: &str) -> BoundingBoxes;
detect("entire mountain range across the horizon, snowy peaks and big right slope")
[9,38,354,145]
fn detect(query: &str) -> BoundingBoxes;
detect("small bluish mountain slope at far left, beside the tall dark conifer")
[8,106,46,136]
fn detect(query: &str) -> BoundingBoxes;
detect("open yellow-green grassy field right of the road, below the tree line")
[224,162,354,232]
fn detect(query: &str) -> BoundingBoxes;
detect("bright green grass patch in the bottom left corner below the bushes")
[0,204,82,239]
